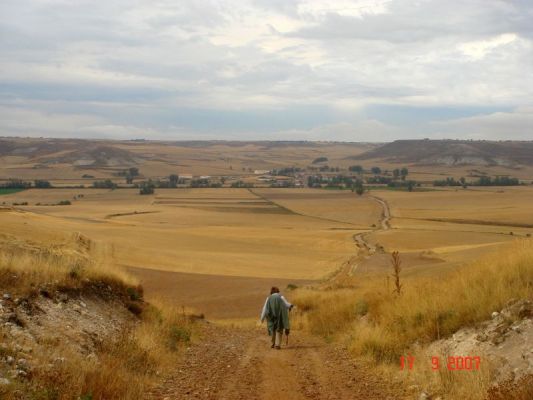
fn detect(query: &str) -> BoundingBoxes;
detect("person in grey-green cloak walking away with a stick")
[261,286,293,350]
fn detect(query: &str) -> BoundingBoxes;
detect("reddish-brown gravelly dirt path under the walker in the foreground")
[148,324,403,400]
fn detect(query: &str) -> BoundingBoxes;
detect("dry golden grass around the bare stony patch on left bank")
[0,235,193,400]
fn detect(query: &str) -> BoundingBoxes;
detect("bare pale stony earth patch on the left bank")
[0,282,141,398]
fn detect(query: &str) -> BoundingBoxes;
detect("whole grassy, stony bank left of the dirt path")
[0,233,191,400]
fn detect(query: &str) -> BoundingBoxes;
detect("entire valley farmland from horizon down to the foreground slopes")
[0,139,533,318]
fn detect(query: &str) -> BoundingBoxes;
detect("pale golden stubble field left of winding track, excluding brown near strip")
[2,188,354,279]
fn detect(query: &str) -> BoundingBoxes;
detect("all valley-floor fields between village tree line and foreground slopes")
[0,182,533,318]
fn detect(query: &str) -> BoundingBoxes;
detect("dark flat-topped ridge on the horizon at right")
[350,139,533,167]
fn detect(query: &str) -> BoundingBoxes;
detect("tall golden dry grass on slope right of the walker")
[295,240,533,363]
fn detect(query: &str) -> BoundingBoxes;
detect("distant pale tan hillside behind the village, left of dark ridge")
[0,137,376,182]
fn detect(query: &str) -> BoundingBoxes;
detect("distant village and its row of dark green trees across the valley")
[0,157,524,195]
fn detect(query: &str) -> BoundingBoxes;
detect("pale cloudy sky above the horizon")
[0,0,533,142]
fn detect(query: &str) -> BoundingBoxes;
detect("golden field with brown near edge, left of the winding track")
[1,189,373,316]
